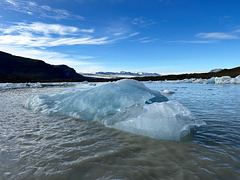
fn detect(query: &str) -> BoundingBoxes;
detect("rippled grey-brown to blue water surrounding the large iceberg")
[0,83,240,180]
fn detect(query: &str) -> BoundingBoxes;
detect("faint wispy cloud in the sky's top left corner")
[0,0,84,20]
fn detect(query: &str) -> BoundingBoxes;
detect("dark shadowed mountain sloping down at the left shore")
[0,51,86,81]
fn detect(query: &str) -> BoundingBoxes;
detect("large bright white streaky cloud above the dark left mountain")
[0,22,110,47]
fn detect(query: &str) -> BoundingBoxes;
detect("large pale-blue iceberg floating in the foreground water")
[26,80,204,141]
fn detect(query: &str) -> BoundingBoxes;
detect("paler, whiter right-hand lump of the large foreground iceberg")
[108,101,205,141]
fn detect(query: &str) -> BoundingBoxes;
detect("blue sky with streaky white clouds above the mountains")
[0,0,240,74]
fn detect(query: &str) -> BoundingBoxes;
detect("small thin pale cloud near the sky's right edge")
[196,32,239,39]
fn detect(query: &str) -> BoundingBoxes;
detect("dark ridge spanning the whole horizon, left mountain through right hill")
[0,51,240,82]
